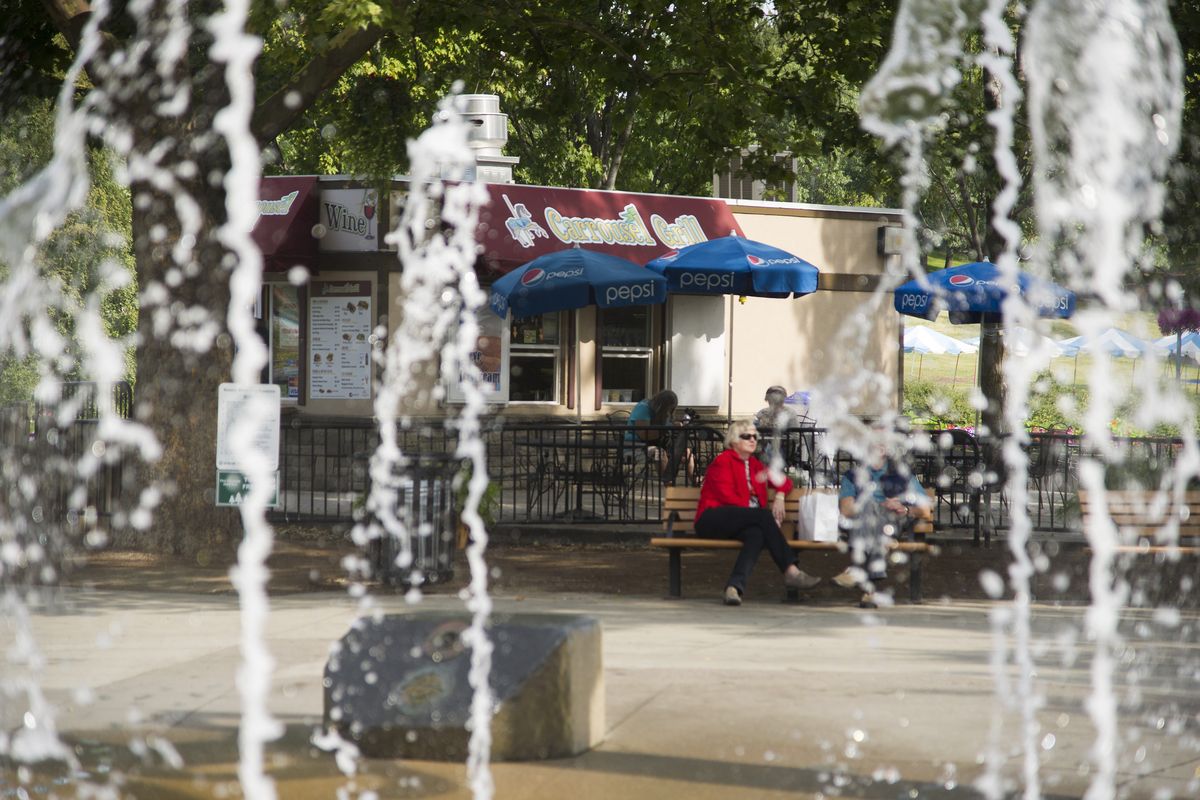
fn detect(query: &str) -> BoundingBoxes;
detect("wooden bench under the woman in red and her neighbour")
[650,486,937,603]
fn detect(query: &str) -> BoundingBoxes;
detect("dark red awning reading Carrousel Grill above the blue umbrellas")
[476,184,743,273]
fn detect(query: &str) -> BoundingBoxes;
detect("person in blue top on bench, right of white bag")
[834,434,932,608]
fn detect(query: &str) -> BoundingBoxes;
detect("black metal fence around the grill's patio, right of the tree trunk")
[276,415,1099,537]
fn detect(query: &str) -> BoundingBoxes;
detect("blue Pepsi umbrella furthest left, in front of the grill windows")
[487,247,667,318]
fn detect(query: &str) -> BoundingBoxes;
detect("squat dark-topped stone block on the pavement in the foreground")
[324,612,605,760]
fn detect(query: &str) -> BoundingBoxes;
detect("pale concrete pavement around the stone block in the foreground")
[0,537,1200,800]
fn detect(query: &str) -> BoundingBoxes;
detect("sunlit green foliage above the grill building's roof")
[262,0,892,196]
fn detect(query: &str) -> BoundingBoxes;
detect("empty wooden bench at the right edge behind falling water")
[1079,489,1200,554]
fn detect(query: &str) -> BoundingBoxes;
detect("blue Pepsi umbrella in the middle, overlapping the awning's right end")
[646,236,820,297]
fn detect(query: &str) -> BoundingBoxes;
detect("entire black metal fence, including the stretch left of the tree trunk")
[0,384,1182,537]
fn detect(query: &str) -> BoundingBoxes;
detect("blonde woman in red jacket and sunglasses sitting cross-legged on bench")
[696,420,821,606]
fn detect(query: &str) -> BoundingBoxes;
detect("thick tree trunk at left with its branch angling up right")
[42,0,382,563]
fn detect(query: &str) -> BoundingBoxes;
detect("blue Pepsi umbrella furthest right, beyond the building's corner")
[895,261,1075,324]
